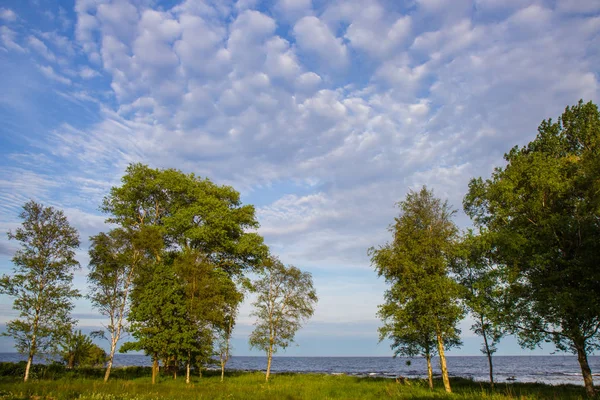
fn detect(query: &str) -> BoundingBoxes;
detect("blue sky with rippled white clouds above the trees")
[0,0,600,356]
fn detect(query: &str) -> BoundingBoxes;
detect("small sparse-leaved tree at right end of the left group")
[249,257,318,381]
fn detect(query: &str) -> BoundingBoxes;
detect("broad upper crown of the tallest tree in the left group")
[103,164,267,274]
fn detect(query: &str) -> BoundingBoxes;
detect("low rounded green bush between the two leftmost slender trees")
[61,330,106,369]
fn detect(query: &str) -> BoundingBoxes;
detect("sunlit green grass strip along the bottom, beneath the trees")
[0,363,586,400]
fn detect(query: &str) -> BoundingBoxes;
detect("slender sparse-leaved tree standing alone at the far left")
[0,201,79,381]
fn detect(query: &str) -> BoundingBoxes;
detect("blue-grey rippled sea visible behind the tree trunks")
[0,353,600,385]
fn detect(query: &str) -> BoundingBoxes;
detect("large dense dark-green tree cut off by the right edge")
[464,101,600,396]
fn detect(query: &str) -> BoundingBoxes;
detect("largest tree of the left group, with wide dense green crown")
[103,164,267,381]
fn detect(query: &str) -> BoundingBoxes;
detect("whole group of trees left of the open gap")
[0,164,317,383]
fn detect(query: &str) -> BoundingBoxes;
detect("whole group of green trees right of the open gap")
[369,101,600,396]
